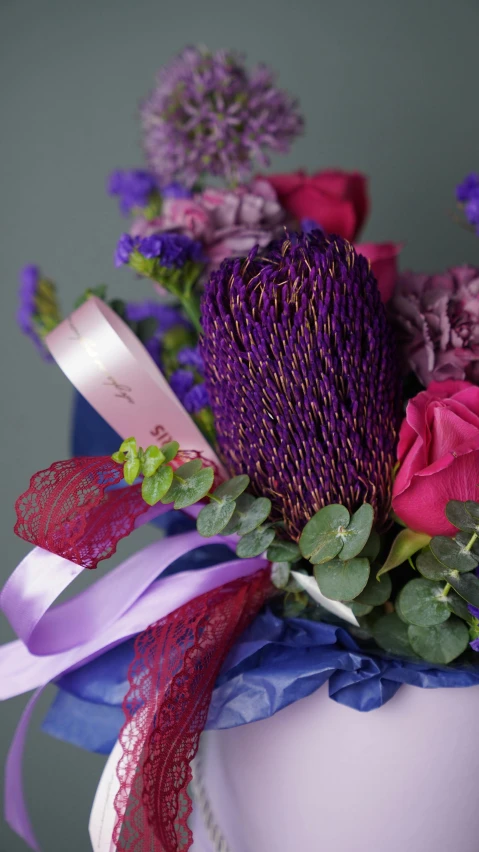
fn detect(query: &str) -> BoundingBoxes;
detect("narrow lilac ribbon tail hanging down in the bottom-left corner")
[5,687,44,852]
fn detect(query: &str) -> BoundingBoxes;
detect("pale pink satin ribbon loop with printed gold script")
[45,296,224,474]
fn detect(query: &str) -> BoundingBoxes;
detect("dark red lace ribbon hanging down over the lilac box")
[113,569,271,852]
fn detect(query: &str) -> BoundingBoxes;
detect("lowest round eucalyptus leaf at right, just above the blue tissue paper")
[407,615,469,665]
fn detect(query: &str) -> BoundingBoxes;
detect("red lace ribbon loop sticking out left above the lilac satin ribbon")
[15,451,221,568]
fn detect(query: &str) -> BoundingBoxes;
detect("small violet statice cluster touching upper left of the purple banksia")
[115,232,203,269]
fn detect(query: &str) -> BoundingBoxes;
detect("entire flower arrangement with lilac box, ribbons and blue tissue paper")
[0,48,479,852]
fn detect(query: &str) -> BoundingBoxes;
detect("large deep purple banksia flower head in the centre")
[200,231,400,538]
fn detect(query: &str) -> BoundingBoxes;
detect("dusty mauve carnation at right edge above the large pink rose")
[389,266,479,387]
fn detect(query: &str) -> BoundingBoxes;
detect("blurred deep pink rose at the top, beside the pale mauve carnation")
[266,169,369,240]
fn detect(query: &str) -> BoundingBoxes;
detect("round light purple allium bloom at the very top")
[142,47,303,186]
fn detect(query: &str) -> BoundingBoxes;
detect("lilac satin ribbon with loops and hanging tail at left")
[0,524,267,849]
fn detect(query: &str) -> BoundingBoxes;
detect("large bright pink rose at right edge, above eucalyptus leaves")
[392,380,479,535]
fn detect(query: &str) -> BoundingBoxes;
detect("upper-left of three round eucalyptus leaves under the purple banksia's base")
[299,503,349,565]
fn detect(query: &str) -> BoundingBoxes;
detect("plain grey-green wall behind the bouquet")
[0,0,479,852]
